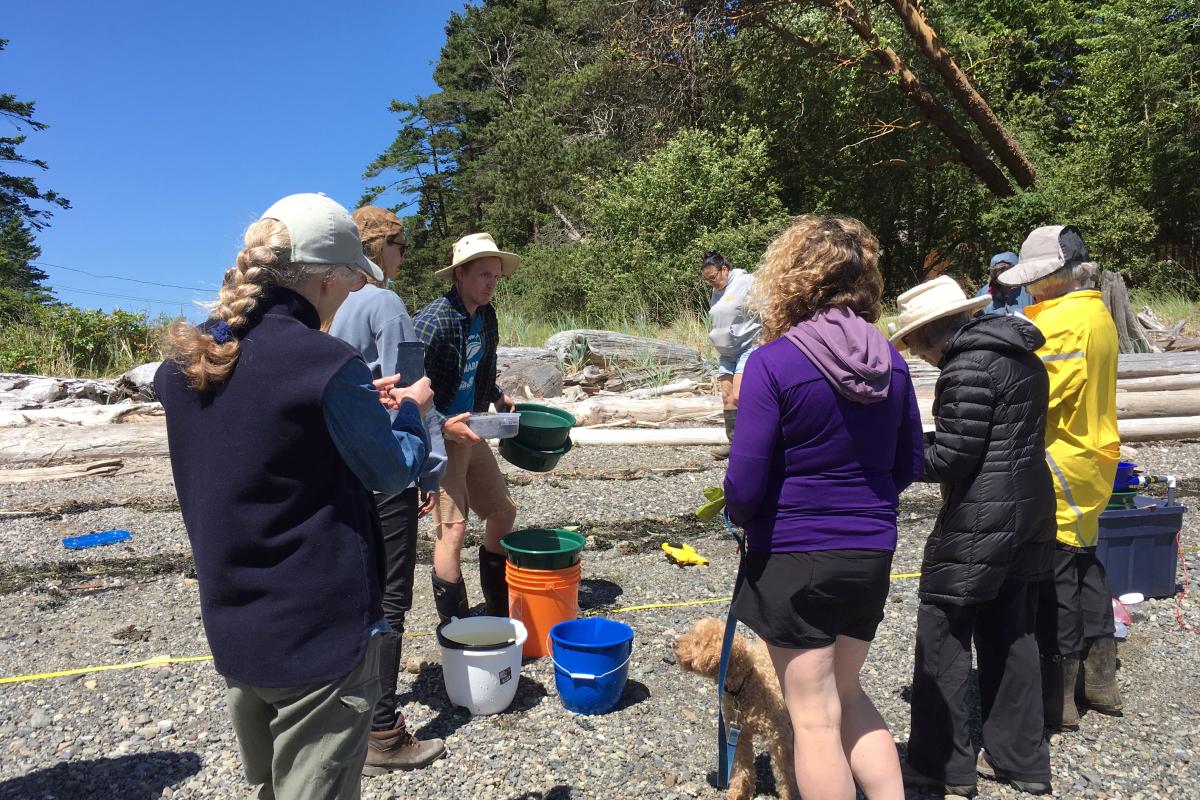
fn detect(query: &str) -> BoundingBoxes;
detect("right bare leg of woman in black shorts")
[834,636,904,800]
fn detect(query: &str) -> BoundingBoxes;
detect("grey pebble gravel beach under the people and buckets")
[0,443,1200,800]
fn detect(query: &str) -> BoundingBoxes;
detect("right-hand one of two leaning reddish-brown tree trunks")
[888,0,1038,188]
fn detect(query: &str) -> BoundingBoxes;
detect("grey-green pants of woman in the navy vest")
[226,636,380,800]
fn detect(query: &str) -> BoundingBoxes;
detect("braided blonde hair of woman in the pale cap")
[167,219,340,391]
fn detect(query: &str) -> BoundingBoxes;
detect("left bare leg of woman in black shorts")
[768,645,854,800]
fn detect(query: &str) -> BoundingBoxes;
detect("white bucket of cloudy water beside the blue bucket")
[438,616,527,715]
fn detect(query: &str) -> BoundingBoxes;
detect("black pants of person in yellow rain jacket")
[1038,545,1114,657]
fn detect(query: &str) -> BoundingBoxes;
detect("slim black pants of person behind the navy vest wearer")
[371,487,420,730]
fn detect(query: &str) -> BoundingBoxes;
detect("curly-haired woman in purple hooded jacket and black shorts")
[725,216,923,800]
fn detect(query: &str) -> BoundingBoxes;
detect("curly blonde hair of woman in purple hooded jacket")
[751,215,883,343]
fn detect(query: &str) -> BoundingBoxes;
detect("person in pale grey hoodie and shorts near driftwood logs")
[700,251,762,458]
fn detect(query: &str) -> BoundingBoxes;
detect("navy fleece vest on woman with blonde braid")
[155,289,383,687]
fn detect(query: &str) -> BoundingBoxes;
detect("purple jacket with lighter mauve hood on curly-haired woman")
[725,309,924,553]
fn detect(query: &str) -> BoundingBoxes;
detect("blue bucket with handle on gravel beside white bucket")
[548,616,634,714]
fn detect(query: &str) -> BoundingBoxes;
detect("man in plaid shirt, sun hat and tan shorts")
[413,233,521,620]
